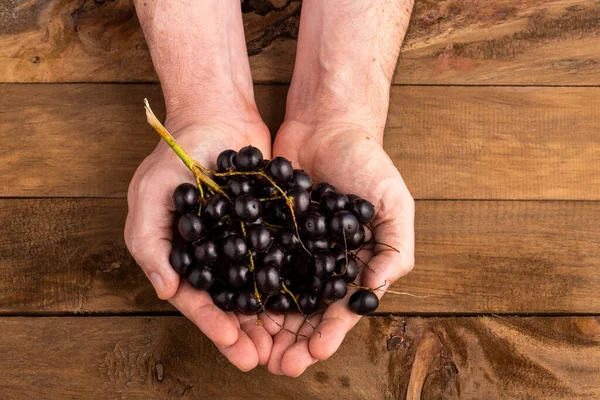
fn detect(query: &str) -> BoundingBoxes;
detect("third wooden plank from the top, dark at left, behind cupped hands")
[0,199,600,315]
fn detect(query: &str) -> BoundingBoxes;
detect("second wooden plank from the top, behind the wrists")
[0,84,600,200]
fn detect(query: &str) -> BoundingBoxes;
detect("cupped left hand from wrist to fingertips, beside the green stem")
[125,114,277,371]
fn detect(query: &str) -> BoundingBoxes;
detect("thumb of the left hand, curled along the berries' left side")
[125,172,179,300]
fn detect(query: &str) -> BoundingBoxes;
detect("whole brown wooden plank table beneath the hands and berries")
[0,0,600,400]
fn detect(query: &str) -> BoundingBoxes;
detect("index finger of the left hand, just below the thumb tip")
[169,282,239,346]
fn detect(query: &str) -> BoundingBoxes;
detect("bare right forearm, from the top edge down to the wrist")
[286,0,413,134]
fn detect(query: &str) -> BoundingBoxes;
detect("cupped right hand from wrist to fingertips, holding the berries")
[268,118,414,376]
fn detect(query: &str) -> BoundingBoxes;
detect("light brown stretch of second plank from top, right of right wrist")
[384,87,600,200]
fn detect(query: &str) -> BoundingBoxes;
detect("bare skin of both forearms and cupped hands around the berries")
[125,0,414,376]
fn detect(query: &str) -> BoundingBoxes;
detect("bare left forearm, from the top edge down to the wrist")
[134,0,256,130]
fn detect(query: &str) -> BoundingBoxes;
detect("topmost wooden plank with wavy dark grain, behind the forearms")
[0,0,600,85]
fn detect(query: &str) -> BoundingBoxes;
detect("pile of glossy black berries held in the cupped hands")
[170,146,379,315]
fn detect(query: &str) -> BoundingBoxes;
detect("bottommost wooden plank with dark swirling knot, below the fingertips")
[0,317,600,400]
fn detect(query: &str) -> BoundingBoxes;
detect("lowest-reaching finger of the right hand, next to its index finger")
[281,314,323,378]
